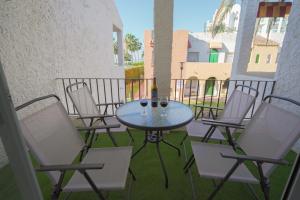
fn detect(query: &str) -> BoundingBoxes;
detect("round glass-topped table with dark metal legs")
[116,100,194,188]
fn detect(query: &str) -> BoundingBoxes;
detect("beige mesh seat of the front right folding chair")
[192,142,259,183]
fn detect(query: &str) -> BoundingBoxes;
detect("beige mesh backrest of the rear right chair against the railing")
[219,85,258,124]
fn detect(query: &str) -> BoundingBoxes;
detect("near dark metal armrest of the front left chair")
[35,163,104,172]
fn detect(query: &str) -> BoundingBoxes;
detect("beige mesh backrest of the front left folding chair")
[20,97,84,183]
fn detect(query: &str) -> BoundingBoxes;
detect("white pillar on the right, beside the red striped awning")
[231,0,259,79]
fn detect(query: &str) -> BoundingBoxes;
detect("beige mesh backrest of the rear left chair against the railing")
[67,82,100,127]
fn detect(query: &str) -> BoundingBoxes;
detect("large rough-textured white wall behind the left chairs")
[0,0,124,167]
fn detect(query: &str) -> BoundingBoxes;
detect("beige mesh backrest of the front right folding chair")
[237,98,300,176]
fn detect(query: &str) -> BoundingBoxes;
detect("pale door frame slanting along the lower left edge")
[0,62,42,200]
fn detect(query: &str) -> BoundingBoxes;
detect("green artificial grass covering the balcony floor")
[0,130,296,200]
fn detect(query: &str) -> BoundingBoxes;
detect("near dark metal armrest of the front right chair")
[220,153,289,165]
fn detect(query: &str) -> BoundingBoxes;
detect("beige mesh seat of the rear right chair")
[186,120,225,140]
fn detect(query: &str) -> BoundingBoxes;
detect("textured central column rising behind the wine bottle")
[154,0,174,96]
